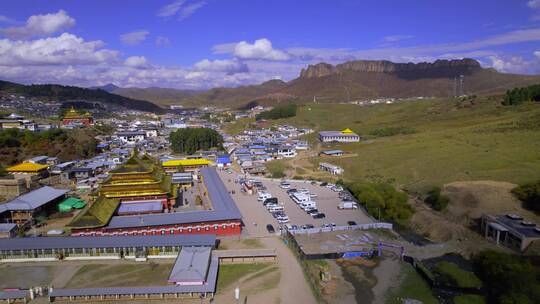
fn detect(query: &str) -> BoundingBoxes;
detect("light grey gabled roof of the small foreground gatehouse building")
[169,247,212,282]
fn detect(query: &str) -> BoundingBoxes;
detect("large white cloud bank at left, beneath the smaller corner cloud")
[0,33,118,66]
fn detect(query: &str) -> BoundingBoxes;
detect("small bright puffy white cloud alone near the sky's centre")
[217,38,291,61]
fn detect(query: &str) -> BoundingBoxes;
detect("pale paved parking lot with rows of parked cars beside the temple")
[219,171,373,236]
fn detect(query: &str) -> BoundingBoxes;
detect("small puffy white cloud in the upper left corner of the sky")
[0,10,75,39]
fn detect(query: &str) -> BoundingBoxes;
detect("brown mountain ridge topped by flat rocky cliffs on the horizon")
[109,58,540,108]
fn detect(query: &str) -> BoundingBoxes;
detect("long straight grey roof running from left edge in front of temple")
[0,234,216,251]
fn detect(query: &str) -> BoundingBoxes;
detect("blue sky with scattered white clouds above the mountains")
[0,0,540,89]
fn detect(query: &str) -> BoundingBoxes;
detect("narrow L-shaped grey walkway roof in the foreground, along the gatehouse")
[49,258,219,297]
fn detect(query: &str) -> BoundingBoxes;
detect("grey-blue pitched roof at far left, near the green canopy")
[4,186,69,210]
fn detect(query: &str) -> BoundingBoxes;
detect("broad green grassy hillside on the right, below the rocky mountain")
[277,98,540,190]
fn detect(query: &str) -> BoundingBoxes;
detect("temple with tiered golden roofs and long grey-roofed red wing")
[69,157,242,236]
